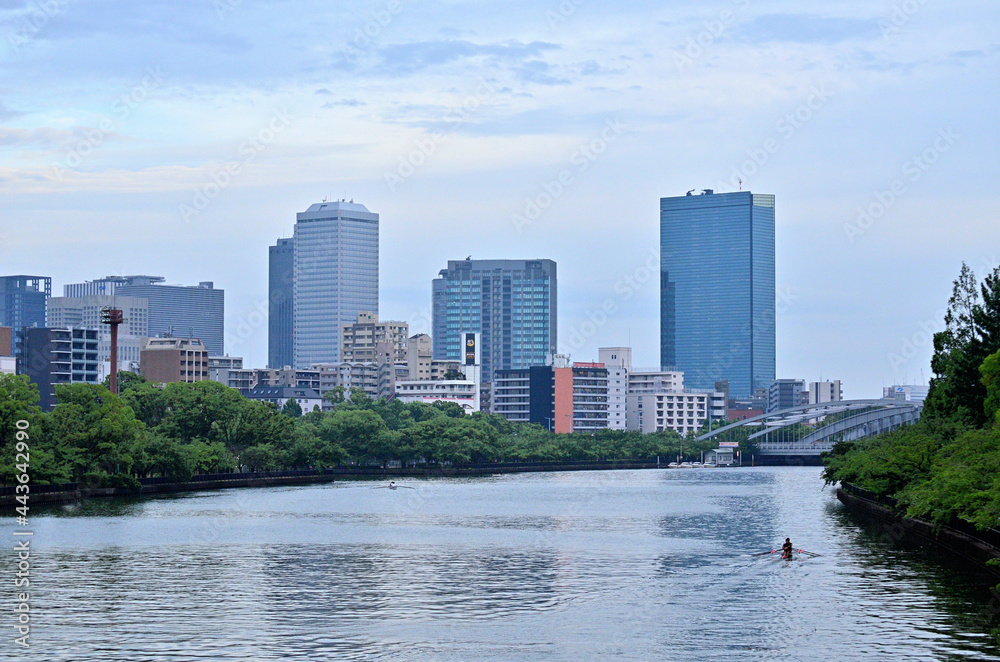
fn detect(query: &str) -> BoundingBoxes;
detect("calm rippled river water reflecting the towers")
[0,467,1000,662]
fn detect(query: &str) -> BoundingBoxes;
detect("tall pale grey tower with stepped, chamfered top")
[292,201,378,368]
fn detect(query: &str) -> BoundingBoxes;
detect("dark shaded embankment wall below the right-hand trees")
[837,483,1000,577]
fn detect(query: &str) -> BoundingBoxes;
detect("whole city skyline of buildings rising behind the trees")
[0,190,896,435]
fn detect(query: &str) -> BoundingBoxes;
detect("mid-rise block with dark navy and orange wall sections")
[491,354,608,434]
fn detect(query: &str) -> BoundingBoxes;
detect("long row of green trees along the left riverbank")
[0,373,740,489]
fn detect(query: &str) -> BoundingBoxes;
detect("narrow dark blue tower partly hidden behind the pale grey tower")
[267,239,295,368]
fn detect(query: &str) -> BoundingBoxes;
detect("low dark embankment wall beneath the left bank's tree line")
[0,459,680,510]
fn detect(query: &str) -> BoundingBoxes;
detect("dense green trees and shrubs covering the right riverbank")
[823,263,1000,642]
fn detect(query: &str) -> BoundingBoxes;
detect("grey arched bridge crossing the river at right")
[696,400,923,460]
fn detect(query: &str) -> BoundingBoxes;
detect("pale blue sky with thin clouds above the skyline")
[0,0,1000,398]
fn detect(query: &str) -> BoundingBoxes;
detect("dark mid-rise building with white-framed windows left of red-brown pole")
[18,327,100,411]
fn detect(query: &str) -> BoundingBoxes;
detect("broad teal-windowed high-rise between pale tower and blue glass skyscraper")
[432,259,556,382]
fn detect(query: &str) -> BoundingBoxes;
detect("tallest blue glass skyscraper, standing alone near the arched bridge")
[660,190,775,399]
